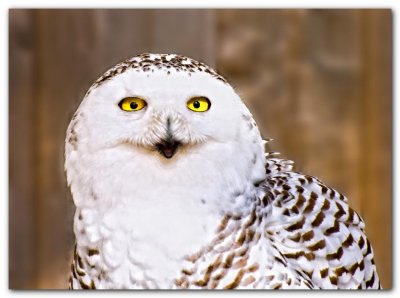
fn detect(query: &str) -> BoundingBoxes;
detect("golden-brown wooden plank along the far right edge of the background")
[360,9,393,289]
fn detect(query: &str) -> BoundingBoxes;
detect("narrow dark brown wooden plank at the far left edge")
[9,9,35,289]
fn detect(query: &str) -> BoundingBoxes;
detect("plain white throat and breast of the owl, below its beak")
[72,141,266,284]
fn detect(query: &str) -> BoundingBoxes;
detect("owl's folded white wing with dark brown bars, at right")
[262,158,381,289]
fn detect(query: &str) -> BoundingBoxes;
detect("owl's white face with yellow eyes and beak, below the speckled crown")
[79,69,253,159]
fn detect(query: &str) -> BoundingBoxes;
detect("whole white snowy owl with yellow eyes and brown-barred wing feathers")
[65,54,380,289]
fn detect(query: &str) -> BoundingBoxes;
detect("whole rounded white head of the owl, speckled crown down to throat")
[65,54,265,208]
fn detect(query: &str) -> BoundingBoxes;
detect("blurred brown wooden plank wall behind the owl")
[9,9,392,289]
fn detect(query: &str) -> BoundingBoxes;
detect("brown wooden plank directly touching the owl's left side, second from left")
[35,10,105,289]
